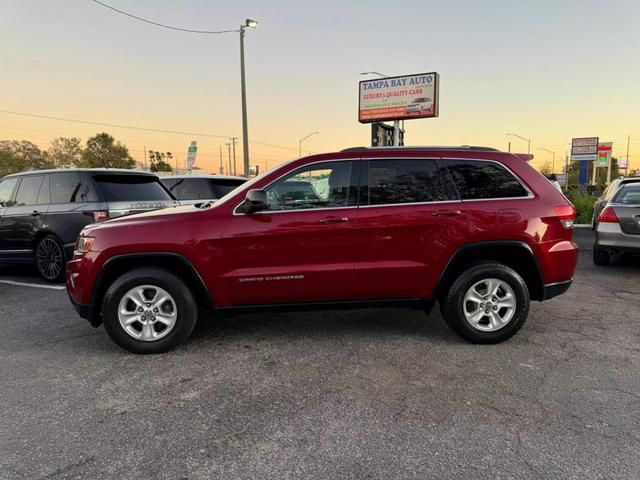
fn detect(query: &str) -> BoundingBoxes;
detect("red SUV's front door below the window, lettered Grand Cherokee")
[222,207,357,305]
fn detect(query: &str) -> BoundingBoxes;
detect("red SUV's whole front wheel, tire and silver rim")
[102,268,198,353]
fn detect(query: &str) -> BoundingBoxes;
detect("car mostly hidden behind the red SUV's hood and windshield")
[160,175,247,205]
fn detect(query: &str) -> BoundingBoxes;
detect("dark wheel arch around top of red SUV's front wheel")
[91,252,214,316]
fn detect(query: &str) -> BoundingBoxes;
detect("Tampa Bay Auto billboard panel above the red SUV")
[358,72,440,123]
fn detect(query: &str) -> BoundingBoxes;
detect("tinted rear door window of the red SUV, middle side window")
[363,160,455,205]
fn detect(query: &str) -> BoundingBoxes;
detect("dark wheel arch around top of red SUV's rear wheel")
[433,241,545,301]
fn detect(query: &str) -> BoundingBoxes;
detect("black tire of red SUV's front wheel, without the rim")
[102,267,198,353]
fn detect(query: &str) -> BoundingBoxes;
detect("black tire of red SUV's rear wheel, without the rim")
[440,262,530,344]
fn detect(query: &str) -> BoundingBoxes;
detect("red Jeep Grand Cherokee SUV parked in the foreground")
[67,147,578,353]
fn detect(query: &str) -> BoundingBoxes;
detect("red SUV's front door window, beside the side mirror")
[265,161,357,211]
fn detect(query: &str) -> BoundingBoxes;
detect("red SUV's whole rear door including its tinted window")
[355,159,469,300]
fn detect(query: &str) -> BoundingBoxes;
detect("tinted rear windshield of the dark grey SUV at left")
[95,175,173,202]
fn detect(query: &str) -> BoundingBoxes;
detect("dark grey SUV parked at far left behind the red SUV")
[0,169,177,282]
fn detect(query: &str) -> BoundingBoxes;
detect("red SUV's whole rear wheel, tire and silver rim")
[441,263,529,343]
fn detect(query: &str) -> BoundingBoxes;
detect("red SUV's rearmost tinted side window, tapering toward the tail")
[445,160,529,200]
